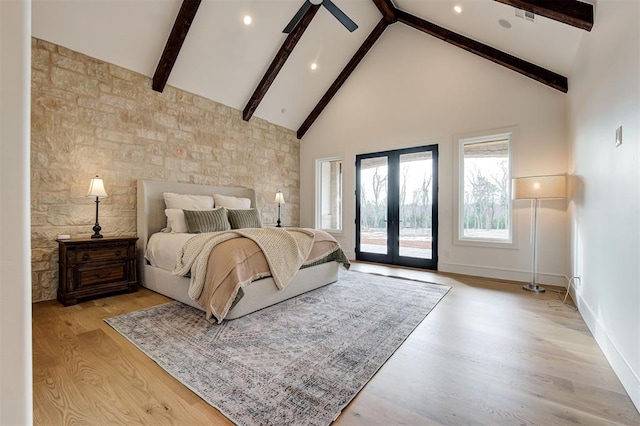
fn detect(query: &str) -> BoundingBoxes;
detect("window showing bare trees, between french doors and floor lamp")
[458,133,512,243]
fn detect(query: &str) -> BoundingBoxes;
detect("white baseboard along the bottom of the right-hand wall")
[570,287,640,412]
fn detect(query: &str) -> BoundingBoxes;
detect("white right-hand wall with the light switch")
[569,0,640,407]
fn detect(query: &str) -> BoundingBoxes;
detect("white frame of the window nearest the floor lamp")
[453,128,519,249]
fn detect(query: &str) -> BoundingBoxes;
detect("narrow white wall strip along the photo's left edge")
[0,0,32,425]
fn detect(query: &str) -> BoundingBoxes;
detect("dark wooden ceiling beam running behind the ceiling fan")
[242,4,320,121]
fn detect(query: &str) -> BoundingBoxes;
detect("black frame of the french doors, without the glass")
[355,144,438,270]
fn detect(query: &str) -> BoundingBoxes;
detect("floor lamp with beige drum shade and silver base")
[511,175,567,293]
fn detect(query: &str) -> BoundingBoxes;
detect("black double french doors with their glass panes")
[356,145,438,269]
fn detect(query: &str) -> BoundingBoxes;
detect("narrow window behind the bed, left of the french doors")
[316,158,342,231]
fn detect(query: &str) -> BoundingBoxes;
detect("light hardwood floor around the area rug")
[33,263,640,425]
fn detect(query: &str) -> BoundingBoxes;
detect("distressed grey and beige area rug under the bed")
[105,270,450,426]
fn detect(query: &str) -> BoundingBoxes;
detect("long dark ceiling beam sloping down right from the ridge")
[396,9,569,93]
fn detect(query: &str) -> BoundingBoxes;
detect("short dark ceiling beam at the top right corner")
[495,0,593,31]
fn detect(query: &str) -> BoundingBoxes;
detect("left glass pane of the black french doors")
[360,157,388,254]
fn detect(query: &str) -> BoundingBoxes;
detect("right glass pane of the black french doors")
[399,151,433,259]
